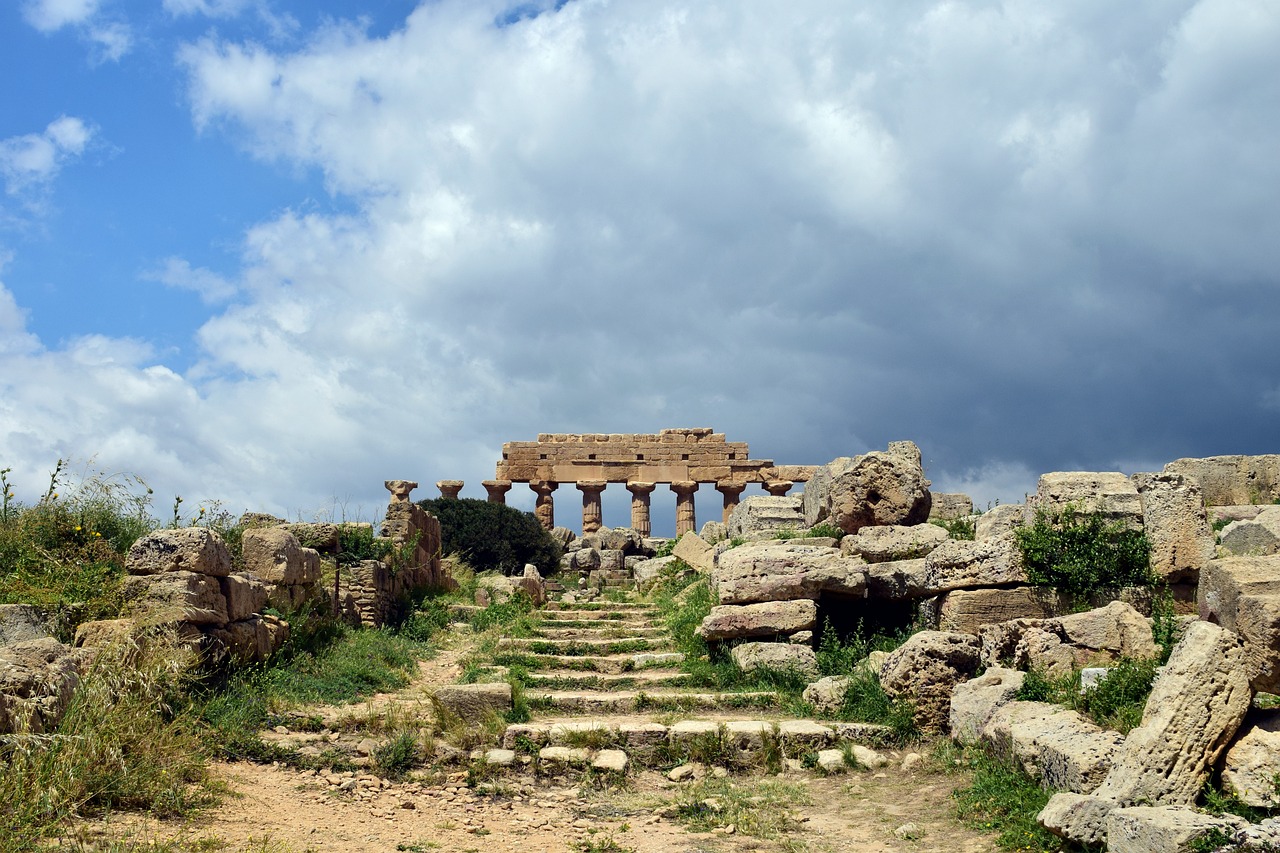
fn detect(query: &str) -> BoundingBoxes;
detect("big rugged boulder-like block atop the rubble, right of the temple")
[803,442,932,533]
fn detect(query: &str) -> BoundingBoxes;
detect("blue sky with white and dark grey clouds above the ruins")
[0,0,1280,533]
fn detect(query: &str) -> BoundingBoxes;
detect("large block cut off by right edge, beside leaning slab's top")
[1197,555,1280,692]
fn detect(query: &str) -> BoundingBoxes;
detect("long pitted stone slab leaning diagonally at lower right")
[1097,622,1253,806]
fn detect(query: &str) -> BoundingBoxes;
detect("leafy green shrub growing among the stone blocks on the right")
[1015,505,1156,598]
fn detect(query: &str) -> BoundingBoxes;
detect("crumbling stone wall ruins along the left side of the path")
[0,480,453,733]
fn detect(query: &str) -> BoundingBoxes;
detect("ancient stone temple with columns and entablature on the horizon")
[484,428,815,537]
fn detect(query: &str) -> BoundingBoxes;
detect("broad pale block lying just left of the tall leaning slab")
[1009,711,1124,794]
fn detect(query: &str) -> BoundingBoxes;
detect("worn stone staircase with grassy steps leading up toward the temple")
[486,591,888,775]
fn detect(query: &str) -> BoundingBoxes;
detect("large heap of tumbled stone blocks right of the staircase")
[650,442,1280,852]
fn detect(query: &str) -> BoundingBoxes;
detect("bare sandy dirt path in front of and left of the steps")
[70,614,995,853]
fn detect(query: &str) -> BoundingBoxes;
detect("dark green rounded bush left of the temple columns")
[419,498,561,575]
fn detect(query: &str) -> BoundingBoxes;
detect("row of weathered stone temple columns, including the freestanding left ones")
[460,480,795,538]
